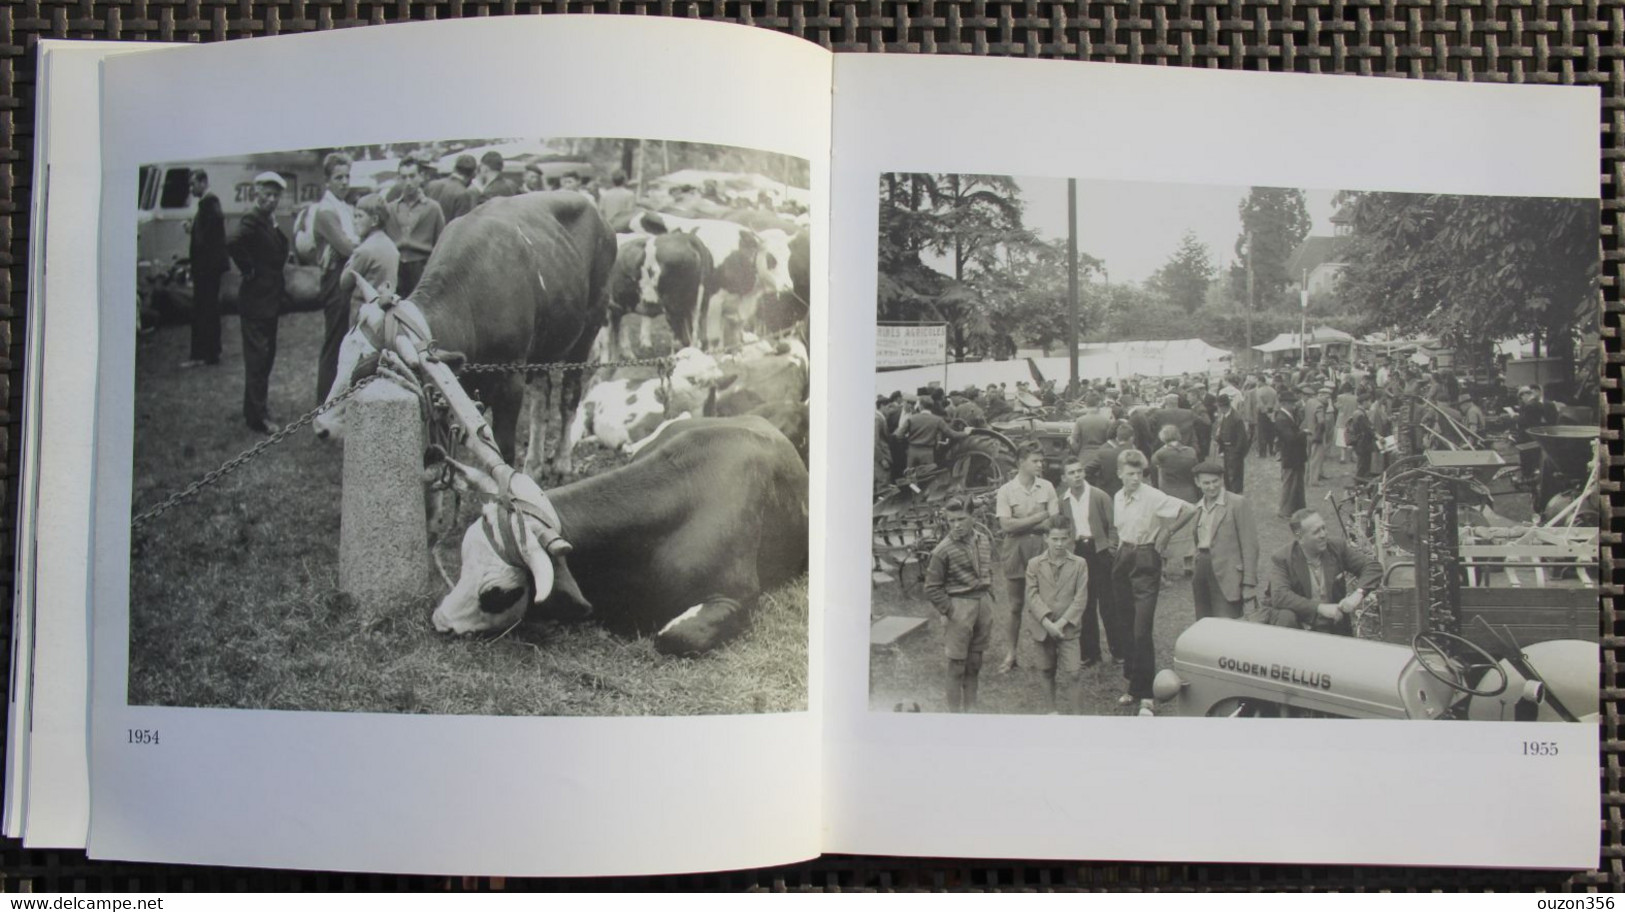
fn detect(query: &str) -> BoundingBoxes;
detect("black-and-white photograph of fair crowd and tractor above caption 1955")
[868,172,1601,725]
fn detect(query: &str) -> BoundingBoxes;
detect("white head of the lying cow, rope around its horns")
[432,454,590,634]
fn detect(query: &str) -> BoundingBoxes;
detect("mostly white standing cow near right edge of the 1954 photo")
[629,213,795,348]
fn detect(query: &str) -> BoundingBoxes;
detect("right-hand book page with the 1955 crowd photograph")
[824,57,1601,868]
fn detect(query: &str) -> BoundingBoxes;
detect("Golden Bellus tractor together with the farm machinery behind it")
[1154,416,1601,722]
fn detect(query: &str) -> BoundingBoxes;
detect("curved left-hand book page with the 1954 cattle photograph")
[89,16,832,875]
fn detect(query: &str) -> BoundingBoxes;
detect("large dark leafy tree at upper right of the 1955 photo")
[1337,193,1599,358]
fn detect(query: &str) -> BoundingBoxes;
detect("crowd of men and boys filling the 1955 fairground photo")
[874,359,1557,715]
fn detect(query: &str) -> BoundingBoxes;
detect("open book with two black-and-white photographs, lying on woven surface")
[7,16,1599,875]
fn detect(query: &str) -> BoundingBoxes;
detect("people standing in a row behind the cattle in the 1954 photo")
[180,151,672,434]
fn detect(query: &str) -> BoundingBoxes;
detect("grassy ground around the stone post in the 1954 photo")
[128,314,808,715]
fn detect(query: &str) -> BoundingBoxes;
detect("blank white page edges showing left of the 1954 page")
[7,41,174,847]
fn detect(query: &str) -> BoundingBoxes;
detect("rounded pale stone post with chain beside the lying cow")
[338,380,429,610]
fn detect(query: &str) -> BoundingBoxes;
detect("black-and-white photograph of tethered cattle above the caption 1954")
[128,137,813,715]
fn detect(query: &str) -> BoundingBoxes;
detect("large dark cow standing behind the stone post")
[315,192,616,478]
